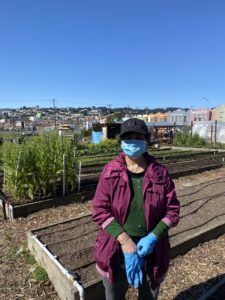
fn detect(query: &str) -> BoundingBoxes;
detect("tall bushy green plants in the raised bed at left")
[3,133,77,202]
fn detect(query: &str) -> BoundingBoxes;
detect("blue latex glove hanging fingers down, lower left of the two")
[123,252,144,288]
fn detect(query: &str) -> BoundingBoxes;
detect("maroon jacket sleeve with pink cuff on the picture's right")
[162,168,180,228]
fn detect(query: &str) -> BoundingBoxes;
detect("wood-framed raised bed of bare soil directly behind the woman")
[28,177,225,300]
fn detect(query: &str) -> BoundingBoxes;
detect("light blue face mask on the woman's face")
[121,140,146,157]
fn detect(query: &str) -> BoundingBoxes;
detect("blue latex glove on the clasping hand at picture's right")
[137,232,158,257]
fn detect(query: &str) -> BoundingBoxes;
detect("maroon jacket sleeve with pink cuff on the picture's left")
[92,165,115,229]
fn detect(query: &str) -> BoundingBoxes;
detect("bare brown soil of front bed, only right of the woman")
[170,177,225,242]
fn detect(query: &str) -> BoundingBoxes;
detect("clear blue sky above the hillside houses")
[0,0,225,108]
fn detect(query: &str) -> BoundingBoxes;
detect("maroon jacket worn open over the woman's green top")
[92,153,180,289]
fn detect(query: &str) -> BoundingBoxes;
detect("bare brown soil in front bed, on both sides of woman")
[34,177,225,283]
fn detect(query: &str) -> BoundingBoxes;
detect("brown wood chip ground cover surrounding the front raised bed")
[0,169,225,300]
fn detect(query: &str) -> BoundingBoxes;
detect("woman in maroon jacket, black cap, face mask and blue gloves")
[93,118,179,300]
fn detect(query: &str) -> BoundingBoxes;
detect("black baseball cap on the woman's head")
[120,118,148,138]
